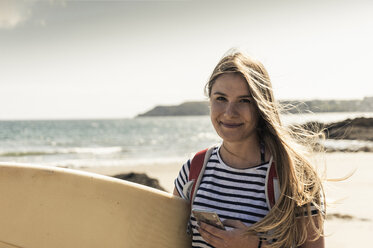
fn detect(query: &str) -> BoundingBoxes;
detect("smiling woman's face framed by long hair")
[210,74,259,142]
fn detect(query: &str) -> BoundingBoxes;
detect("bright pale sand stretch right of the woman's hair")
[316,153,373,248]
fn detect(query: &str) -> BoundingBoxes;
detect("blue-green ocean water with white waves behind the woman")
[0,113,373,169]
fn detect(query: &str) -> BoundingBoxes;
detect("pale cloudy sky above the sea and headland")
[0,0,373,120]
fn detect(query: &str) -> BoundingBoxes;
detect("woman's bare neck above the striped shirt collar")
[220,139,261,169]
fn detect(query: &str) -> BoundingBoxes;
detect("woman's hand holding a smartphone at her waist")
[199,220,259,248]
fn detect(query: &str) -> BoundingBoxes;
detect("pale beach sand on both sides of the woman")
[85,152,373,248]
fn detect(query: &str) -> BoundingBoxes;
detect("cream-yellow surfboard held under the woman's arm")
[0,163,191,248]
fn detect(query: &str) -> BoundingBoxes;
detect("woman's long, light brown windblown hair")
[205,51,325,248]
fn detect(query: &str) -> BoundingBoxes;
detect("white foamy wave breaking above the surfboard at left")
[0,146,126,157]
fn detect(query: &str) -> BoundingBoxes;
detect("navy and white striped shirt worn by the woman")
[175,147,269,247]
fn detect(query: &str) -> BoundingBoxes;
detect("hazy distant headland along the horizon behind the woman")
[137,97,373,117]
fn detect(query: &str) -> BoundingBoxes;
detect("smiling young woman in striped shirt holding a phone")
[174,52,325,248]
